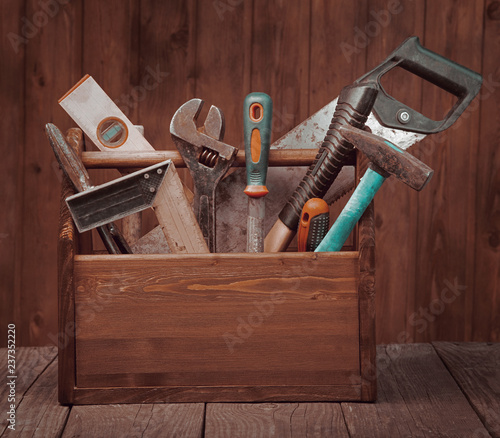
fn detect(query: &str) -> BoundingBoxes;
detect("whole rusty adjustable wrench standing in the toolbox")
[170,99,238,252]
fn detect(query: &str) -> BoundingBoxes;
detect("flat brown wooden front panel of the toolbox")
[74,252,361,388]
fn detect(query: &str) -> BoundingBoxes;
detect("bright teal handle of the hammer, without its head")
[315,168,386,252]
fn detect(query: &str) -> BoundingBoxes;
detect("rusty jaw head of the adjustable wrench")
[170,99,238,179]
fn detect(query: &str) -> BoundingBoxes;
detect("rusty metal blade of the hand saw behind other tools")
[216,98,425,252]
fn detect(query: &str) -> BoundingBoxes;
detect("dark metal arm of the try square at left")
[66,160,171,233]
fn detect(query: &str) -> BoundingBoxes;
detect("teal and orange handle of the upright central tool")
[243,93,273,198]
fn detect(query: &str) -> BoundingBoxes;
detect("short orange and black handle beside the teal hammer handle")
[297,198,330,252]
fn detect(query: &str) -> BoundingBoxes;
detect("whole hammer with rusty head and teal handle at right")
[315,125,434,252]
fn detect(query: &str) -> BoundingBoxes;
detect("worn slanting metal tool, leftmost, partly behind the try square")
[45,123,132,254]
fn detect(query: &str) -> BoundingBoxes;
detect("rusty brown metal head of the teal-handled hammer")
[339,125,434,190]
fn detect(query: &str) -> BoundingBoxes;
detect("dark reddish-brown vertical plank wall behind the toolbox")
[0,0,500,346]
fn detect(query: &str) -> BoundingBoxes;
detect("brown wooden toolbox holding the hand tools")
[55,151,376,404]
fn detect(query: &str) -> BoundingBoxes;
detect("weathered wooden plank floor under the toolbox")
[0,342,500,438]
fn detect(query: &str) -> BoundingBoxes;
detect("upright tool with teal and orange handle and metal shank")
[243,93,273,252]
